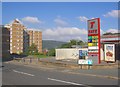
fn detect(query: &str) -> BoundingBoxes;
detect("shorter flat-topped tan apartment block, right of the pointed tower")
[27,29,42,53]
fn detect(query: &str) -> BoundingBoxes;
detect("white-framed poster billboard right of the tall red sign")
[104,44,115,62]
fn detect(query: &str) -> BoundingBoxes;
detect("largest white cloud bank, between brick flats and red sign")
[42,27,87,41]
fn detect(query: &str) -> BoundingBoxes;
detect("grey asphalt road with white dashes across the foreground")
[2,63,118,86]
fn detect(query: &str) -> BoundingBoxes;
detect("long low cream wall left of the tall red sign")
[56,48,88,60]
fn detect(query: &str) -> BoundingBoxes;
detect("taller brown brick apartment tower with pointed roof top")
[10,19,28,54]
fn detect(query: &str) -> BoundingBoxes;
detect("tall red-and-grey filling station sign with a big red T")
[88,18,100,63]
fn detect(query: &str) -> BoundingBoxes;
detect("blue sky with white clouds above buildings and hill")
[2,2,119,41]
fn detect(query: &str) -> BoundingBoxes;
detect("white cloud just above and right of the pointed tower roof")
[22,16,42,23]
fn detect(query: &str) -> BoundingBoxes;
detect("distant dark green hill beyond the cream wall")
[42,40,67,50]
